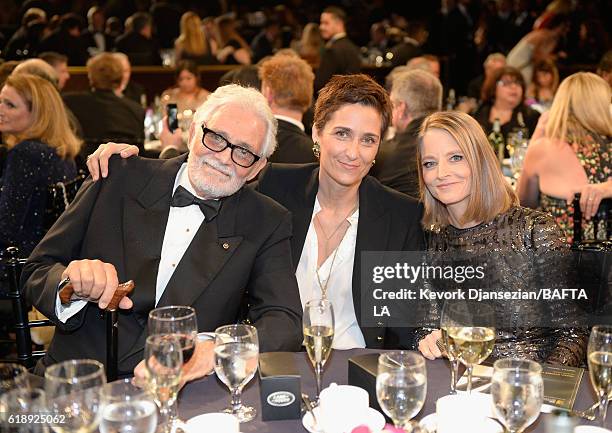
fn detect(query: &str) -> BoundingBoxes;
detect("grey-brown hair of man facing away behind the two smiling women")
[391,69,442,118]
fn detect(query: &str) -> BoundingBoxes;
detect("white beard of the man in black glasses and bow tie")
[187,152,246,198]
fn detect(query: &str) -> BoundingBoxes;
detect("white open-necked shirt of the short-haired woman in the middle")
[295,197,365,350]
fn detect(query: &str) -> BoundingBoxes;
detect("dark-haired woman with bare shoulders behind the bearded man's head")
[161,60,210,118]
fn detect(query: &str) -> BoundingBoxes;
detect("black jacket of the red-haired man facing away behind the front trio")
[269,119,316,164]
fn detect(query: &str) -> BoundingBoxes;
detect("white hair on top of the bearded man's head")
[194,84,277,158]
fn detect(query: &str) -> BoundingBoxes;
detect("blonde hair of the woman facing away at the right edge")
[546,72,612,142]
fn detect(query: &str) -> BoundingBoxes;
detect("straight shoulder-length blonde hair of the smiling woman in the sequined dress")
[417,111,519,227]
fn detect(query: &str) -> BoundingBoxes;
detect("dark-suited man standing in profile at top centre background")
[315,6,361,92]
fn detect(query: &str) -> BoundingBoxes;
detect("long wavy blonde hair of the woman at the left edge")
[4,74,81,159]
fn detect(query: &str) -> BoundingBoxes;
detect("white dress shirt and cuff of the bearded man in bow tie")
[55,163,204,323]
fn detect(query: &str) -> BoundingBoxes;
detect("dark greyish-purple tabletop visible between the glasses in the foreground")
[178,349,612,433]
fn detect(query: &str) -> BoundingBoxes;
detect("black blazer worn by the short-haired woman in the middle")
[256,164,424,349]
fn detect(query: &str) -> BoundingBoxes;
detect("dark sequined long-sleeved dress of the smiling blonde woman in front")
[426,207,588,366]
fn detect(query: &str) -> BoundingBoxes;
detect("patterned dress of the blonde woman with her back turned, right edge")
[539,135,612,242]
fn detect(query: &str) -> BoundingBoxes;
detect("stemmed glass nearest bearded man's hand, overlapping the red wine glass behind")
[145,334,183,433]
